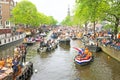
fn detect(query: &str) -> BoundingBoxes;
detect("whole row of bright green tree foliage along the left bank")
[11,0,57,27]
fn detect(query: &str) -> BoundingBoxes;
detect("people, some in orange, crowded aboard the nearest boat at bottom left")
[0,44,27,74]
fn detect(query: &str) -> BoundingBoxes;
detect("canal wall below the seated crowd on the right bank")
[100,45,120,62]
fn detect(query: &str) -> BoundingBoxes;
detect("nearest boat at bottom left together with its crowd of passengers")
[0,44,33,80]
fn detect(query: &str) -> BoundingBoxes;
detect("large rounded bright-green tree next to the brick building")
[11,0,39,26]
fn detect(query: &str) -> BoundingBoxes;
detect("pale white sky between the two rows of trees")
[14,0,75,22]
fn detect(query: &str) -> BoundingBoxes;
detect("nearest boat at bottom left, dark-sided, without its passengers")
[0,62,33,80]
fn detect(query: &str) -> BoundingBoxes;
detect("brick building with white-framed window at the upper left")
[0,0,15,28]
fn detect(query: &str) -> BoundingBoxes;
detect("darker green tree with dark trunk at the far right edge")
[104,0,120,35]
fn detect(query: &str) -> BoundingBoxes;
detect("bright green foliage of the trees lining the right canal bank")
[74,0,120,34]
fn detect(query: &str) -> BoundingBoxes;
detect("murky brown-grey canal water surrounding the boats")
[0,40,120,80]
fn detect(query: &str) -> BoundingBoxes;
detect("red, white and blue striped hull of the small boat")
[74,55,93,66]
